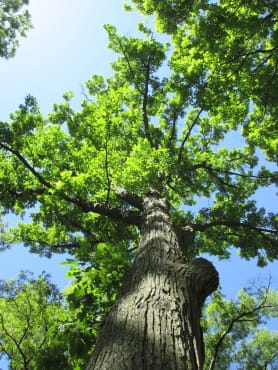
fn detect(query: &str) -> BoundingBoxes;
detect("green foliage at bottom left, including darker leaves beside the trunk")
[0,268,103,370]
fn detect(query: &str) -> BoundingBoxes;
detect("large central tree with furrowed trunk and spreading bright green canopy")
[0,0,278,370]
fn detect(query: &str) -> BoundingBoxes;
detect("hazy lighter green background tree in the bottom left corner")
[0,272,69,370]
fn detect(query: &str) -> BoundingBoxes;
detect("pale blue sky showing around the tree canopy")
[0,0,278,366]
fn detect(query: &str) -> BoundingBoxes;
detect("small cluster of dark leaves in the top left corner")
[0,0,32,58]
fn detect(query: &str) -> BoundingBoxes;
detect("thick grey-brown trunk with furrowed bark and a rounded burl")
[86,195,218,370]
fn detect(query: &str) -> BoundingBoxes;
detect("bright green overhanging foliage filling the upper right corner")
[132,0,278,162]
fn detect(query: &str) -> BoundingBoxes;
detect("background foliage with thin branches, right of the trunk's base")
[203,286,278,370]
